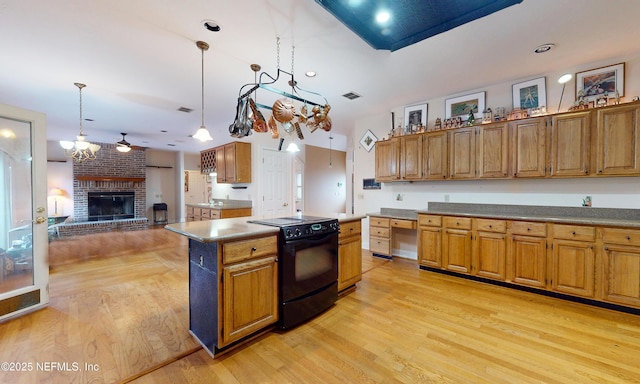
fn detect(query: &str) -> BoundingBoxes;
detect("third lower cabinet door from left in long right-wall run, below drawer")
[472,232,507,281]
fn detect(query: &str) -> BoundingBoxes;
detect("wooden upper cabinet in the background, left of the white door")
[215,141,251,184]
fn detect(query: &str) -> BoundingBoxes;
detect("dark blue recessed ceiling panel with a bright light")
[315,0,523,51]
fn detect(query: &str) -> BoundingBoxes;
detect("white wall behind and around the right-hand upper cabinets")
[351,50,640,258]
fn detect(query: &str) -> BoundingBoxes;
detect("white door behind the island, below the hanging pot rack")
[260,148,294,217]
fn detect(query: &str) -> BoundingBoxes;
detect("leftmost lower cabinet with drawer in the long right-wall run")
[418,215,442,268]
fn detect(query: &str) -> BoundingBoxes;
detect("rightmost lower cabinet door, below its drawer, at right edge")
[603,244,640,308]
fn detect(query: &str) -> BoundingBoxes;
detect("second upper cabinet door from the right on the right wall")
[549,111,592,177]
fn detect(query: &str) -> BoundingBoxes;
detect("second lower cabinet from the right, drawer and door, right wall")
[551,224,596,298]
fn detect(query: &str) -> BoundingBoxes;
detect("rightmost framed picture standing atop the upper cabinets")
[576,63,624,101]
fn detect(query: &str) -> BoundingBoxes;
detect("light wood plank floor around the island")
[0,232,640,384]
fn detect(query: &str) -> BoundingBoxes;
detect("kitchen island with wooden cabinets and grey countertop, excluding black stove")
[165,214,364,356]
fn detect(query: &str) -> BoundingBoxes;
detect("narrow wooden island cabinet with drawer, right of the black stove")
[338,219,362,292]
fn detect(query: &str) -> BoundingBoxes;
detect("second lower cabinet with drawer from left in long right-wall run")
[442,216,471,273]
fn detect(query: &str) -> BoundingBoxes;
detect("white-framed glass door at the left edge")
[0,104,49,321]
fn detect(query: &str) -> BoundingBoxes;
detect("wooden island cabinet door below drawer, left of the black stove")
[219,256,278,347]
